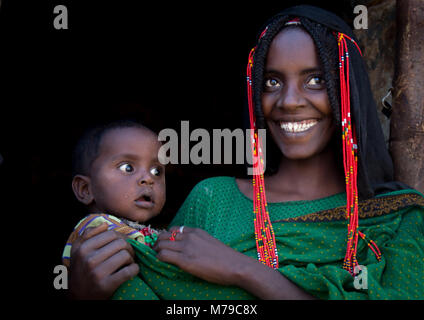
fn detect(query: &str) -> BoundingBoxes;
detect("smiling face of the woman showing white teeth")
[262,28,335,160]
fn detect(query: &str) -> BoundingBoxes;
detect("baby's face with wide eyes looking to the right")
[91,128,165,222]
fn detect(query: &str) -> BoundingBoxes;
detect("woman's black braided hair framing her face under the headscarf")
[252,16,342,174]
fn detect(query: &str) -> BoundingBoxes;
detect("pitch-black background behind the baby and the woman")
[0,0,353,298]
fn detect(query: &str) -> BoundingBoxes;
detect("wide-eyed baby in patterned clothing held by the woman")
[62,121,166,267]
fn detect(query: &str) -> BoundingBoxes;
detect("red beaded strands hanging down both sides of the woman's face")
[247,18,381,276]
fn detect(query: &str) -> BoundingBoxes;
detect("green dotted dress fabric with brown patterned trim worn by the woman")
[113,177,424,300]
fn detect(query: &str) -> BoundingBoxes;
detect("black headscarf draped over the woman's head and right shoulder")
[255,5,409,200]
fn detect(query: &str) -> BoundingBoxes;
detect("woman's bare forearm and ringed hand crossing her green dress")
[153,227,314,300]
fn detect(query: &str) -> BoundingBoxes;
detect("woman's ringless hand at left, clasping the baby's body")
[69,223,139,300]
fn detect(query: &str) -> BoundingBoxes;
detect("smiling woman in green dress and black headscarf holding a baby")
[70,6,424,299]
